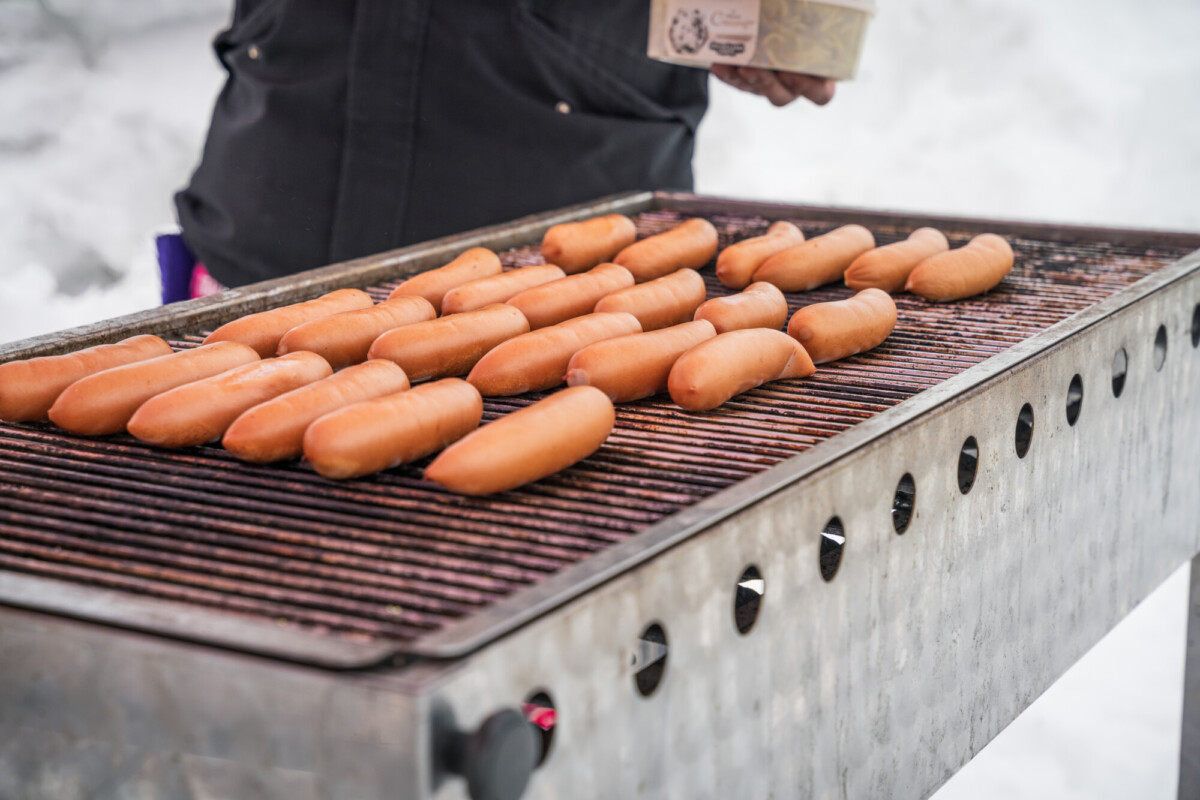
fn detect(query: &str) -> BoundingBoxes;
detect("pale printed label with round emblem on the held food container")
[666,0,760,64]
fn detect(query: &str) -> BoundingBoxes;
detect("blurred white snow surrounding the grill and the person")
[0,0,1200,800]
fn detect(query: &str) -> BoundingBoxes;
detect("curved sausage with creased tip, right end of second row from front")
[667,327,816,411]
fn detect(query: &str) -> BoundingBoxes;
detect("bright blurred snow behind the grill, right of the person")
[696,0,1200,230]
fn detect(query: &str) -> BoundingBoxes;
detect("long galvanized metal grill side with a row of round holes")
[436,260,1200,800]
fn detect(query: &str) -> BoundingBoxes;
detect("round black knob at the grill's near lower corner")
[444,709,538,800]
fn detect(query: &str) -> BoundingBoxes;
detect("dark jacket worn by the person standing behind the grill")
[175,0,708,285]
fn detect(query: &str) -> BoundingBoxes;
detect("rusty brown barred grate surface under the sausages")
[0,211,1186,657]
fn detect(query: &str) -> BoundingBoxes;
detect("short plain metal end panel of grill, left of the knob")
[0,607,432,800]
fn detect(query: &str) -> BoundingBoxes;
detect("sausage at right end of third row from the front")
[787,289,896,363]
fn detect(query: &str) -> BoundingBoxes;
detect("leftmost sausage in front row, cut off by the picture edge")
[0,336,170,422]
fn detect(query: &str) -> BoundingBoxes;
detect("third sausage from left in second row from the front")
[367,302,529,380]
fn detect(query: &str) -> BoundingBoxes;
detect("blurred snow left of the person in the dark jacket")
[0,0,228,342]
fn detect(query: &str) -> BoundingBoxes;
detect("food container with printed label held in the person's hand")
[646,0,875,80]
